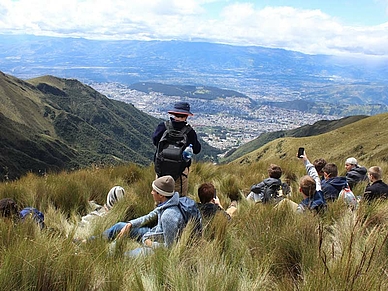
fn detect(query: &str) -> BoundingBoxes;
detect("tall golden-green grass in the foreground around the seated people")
[0,161,388,290]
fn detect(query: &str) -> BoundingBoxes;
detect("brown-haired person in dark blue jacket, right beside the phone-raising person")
[321,163,348,201]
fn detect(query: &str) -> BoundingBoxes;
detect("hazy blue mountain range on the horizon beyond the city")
[0,35,388,116]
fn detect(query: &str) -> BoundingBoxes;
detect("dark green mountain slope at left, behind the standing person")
[0,72,218,180]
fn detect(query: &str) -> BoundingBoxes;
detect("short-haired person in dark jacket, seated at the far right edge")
[364,166,388,201]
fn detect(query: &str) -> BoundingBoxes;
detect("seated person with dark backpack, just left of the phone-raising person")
[247,164,291,203]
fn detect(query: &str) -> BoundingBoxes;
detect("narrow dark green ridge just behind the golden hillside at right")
[221,115,367,163]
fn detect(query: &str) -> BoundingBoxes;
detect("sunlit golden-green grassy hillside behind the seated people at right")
[232,113,388,169]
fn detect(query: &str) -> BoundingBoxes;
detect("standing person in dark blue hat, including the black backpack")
[152,102,201,196]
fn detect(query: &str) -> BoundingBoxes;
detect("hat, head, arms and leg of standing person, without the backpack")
[152,102,201,196]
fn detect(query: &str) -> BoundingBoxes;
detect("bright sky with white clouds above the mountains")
[0,0,388,57]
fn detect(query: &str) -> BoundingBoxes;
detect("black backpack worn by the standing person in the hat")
[155,120,192,180]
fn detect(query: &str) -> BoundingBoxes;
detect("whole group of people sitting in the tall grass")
[0,152,388,257]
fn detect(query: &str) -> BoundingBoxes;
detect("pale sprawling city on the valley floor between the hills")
[90,83,340,152]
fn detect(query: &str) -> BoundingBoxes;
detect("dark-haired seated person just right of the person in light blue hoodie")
[197,183,231,219]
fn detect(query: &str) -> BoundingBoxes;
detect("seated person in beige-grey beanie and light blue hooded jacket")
[103,176,184,256]
